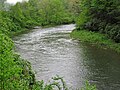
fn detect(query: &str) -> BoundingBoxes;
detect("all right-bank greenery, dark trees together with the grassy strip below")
[71,0,120,52]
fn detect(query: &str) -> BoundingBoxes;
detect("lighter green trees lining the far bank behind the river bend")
[0,0,74,33]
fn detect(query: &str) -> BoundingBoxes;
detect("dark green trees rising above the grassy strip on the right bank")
[77,0,120,43]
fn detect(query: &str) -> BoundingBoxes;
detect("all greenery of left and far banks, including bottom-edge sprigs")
[0,0,96,90]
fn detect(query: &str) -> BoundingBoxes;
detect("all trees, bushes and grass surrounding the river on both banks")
[0,0,120,90]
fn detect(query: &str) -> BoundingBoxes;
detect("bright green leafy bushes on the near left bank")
[0,33,34,90]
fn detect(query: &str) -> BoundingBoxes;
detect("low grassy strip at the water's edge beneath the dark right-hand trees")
[70,30,120,53]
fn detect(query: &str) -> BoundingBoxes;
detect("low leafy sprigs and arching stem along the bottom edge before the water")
[32,75,97,90]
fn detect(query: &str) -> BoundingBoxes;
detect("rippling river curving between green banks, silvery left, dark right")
[13,24,120,90]
